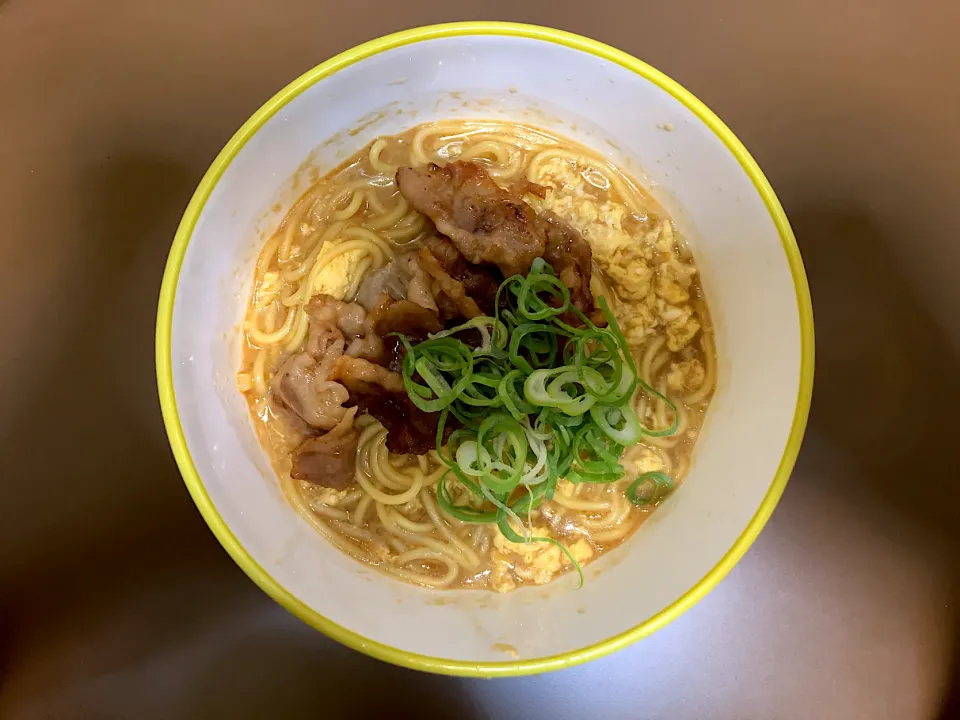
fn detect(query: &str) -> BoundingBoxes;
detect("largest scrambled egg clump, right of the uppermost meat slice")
[530,158,700,352]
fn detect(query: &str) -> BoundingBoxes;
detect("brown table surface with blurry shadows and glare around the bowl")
[0,0,960,720]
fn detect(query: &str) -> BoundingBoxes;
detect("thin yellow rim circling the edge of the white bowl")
[156,22,814,677]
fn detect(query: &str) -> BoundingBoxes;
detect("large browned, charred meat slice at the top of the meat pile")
[397,162,546,276]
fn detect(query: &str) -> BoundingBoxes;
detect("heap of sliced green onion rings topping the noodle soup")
[400,258,679,585]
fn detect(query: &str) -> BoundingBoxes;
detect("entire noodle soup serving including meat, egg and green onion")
[237,121,717,592]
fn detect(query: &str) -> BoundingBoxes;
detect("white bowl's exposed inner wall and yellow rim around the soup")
[157,23,813,675]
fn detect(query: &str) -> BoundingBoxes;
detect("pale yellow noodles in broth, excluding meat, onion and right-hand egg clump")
[238,120,717,589]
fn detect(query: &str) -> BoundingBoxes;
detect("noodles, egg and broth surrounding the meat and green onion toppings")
[237,121,716,592]
